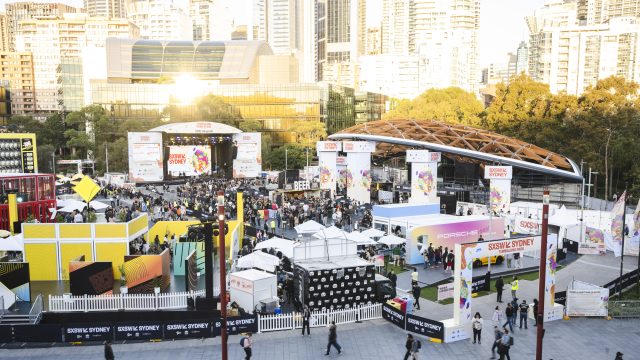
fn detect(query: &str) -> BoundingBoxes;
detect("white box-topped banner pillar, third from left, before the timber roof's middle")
[406,150,441,203]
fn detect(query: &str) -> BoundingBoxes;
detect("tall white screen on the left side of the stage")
[128,132,164,182]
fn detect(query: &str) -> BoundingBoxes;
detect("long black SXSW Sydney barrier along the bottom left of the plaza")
[0,315,258,343]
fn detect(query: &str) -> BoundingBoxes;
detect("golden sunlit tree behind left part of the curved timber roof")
[384,87,483,126]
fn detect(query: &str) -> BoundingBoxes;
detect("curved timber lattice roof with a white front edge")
[329,120,582,181]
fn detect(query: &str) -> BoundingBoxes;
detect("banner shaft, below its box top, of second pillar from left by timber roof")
[345,152,371,204]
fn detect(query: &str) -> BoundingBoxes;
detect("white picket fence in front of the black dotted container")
[258,304,382,332]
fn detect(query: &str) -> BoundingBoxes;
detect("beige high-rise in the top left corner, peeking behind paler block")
[5,2,78,51]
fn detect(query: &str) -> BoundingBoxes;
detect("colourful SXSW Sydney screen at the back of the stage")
[167,145,211,176]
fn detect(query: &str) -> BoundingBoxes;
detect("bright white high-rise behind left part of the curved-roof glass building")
[125,0,191,40]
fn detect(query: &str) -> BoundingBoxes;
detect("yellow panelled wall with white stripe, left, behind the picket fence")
[22,214,149,281]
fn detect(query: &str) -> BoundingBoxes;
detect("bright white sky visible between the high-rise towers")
[0,0,545,67]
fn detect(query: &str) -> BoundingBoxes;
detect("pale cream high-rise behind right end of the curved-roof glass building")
[251,0,302,54]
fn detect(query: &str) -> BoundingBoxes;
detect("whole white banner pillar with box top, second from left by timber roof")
[342,141,376,204]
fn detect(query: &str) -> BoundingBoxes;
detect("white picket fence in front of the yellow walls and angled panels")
[48,290,205,312]
